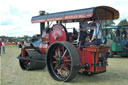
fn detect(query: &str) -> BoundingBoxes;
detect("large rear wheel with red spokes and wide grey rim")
[46,42,80,82]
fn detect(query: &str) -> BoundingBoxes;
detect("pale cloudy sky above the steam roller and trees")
[0,0,128,36]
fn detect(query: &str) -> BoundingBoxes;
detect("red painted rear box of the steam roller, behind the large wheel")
[77,46,109,73]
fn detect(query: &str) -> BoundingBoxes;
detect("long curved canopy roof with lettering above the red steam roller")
[32,6,119,23]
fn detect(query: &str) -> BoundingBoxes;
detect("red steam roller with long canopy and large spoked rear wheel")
[18,6,119,81]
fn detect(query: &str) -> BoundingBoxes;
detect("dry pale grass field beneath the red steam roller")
[0,46,128,85]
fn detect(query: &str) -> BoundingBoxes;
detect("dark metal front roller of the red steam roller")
[19,50,46,70]
